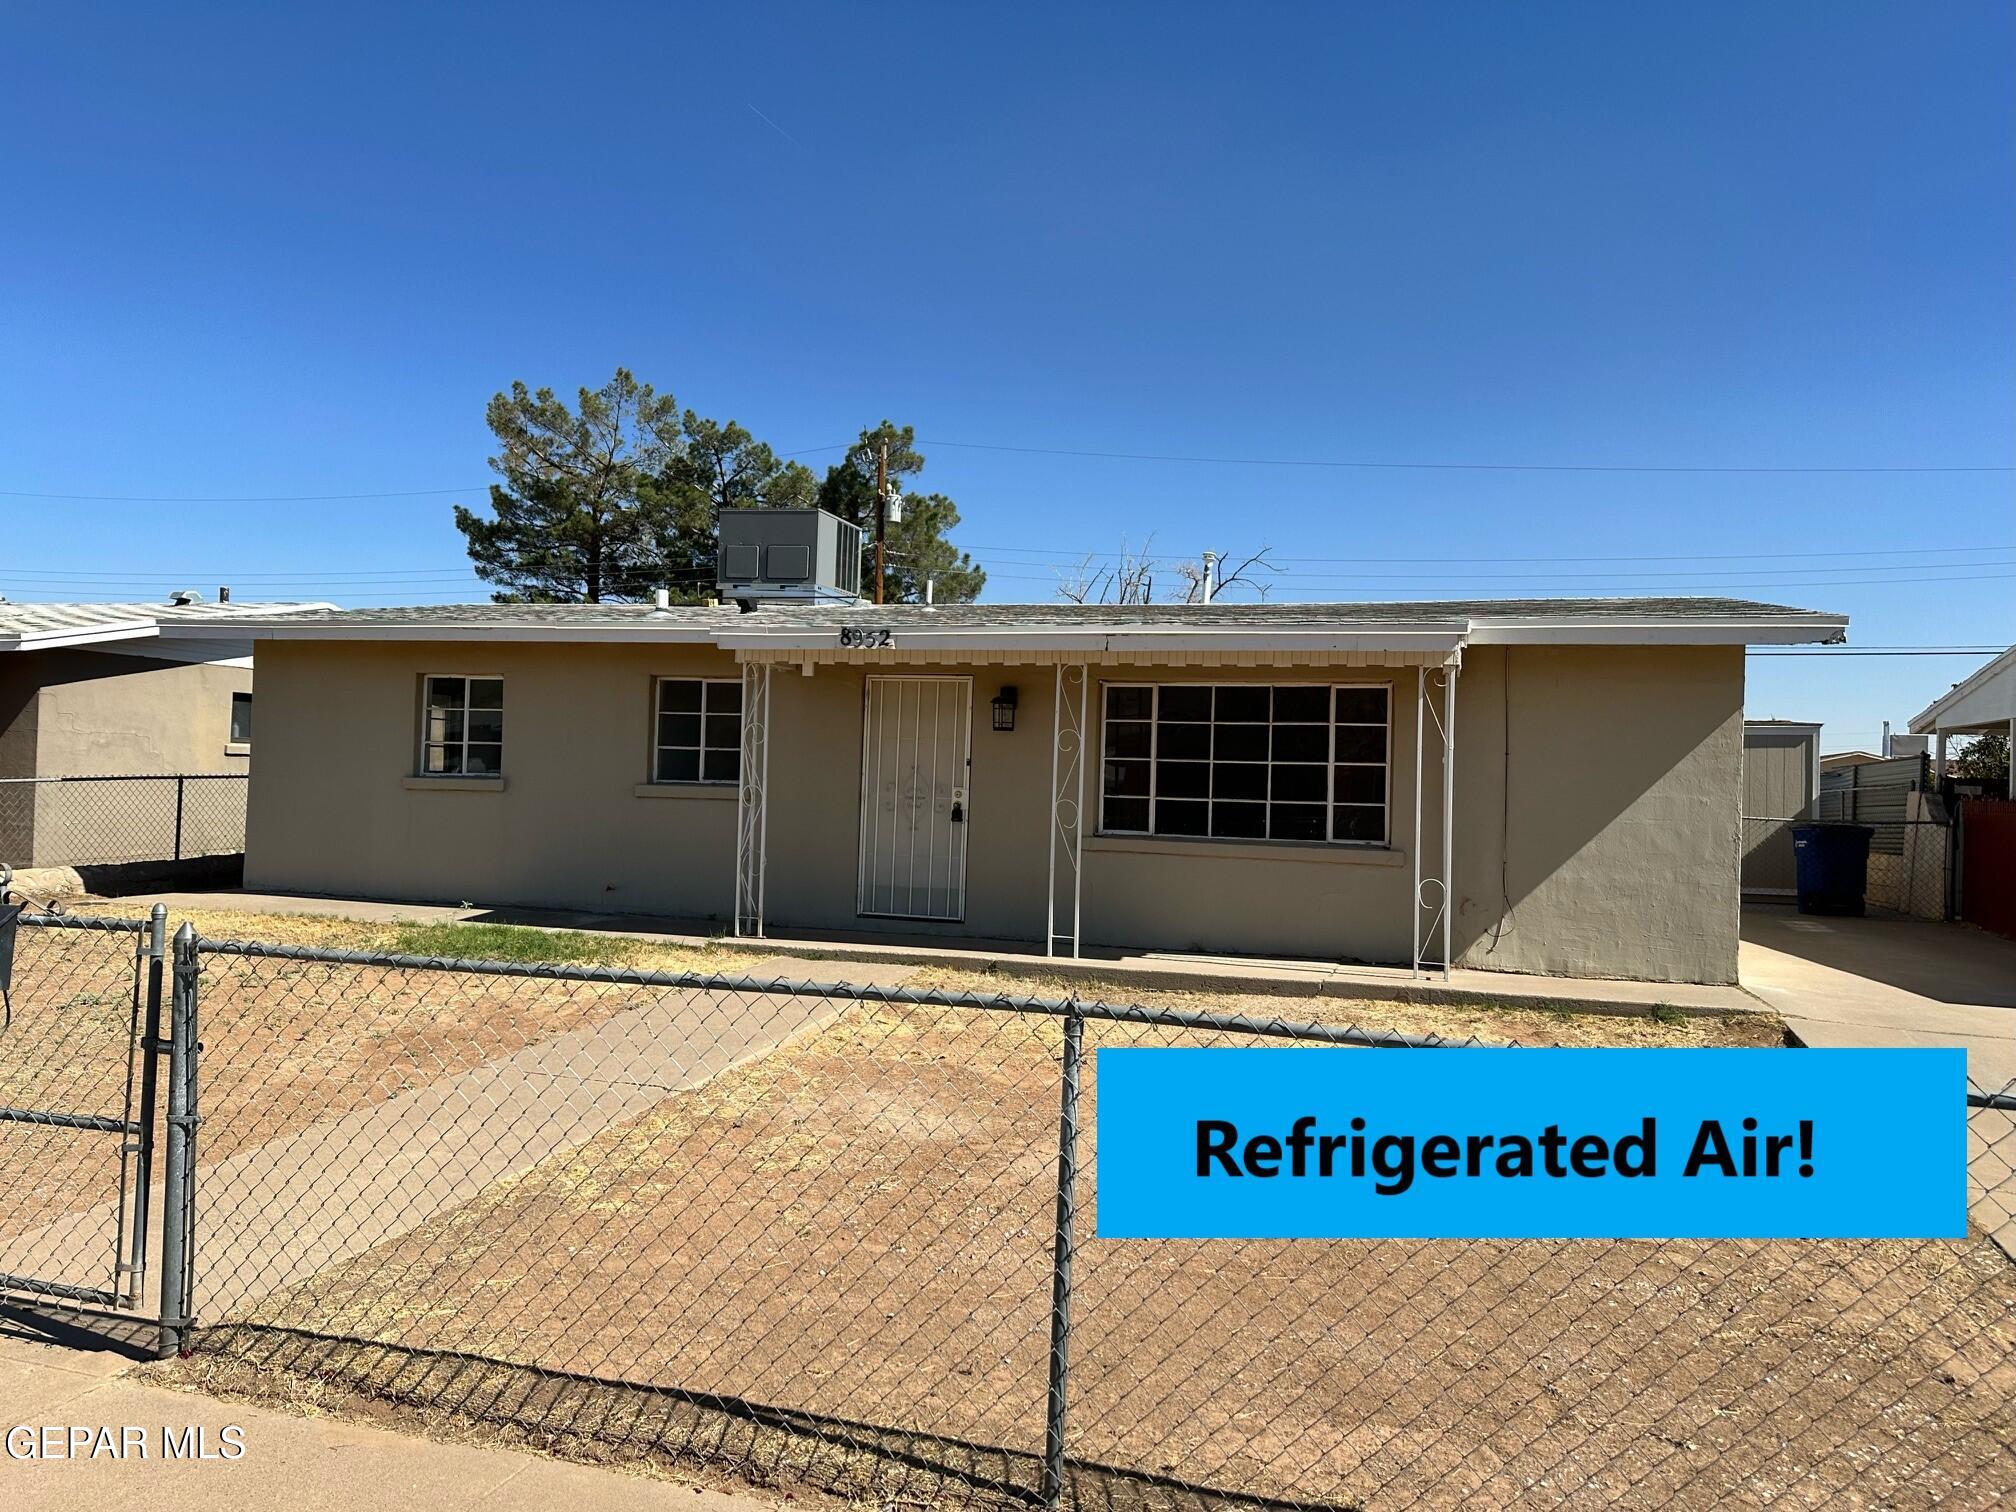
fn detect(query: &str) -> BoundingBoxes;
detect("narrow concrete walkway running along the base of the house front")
[98,891,1758,1014]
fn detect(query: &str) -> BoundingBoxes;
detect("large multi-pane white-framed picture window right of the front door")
[1099,683,1393,845]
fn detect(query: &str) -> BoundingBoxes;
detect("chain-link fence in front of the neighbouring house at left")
[0,772,248,867]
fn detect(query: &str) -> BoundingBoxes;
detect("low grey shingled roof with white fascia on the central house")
[181,599,1849,649]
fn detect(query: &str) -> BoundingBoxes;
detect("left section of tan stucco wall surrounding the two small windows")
[246,641,749,919]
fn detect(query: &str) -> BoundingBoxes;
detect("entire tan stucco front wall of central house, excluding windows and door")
[246,641,1742,982]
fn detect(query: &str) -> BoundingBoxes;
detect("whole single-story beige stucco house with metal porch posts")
[192,599,1847,982]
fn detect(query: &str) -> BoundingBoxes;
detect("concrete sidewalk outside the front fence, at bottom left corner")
[0,1314,786,1512]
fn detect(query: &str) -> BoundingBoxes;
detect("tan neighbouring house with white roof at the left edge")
[0,595,327,867]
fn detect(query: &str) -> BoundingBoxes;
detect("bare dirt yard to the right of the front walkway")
[177,1006,2016,1508]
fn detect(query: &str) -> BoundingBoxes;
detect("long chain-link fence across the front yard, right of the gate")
[67,941,1983,1508]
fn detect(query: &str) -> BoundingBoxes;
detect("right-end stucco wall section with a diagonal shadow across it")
[1456,647,1744,982]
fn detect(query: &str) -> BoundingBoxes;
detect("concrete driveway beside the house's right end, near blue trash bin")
[1740,905,2016,1256]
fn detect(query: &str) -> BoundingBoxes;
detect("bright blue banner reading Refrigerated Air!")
[1095,1046,1968,1240]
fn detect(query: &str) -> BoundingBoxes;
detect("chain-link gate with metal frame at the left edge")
[0,903,196,1353]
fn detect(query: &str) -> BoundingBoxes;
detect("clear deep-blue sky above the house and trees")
[0,0,2016,746]
